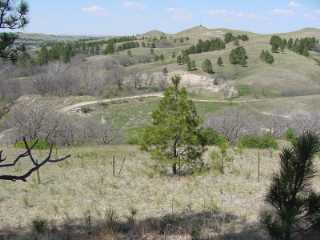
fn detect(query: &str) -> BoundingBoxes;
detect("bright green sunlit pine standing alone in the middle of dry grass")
[141,76,206,175]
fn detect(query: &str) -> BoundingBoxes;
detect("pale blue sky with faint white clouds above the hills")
[24,0,320,35]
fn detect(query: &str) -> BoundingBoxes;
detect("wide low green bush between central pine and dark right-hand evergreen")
[238,134,278,149]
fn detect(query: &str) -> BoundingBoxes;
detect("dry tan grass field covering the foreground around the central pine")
[0,143,320,239]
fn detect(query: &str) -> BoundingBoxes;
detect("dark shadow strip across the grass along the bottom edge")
[0,211,267,240]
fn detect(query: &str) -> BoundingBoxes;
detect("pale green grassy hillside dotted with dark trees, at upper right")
[120,26,320,97]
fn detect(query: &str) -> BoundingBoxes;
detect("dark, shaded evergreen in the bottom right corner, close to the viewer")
[262,132,320,240]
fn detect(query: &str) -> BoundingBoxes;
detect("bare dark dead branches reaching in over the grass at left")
[0,138,71,182]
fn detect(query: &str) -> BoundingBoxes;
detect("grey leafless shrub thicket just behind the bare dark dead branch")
[6,103,120,146]
